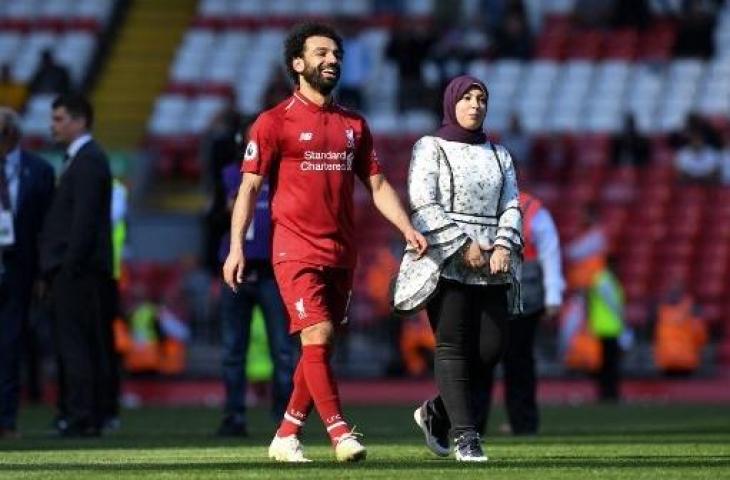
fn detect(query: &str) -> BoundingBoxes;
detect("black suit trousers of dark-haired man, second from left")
[51,270,110,429]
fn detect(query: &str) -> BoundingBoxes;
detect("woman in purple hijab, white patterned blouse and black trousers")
[393,75,522,462]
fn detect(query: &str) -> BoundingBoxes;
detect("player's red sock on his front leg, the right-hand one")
[299,345,350,443]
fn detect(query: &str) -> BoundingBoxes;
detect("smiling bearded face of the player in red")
[292,36,342,95]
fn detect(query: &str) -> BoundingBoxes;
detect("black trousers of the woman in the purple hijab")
[427,280,507,438]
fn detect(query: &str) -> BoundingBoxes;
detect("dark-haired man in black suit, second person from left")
[40,95,112,437]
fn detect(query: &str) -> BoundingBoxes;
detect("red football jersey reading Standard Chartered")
[241,92,380,267]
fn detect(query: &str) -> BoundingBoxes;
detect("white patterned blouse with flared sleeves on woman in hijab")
[394,136,523,313]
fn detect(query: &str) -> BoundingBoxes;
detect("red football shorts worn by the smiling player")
[274,262,353,333]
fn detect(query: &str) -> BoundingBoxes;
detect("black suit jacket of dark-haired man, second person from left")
[40,140,112,275]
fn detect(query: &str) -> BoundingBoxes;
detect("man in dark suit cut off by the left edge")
[0,107,54,438]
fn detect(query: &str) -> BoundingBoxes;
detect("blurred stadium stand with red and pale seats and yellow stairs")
[5,0,730,376]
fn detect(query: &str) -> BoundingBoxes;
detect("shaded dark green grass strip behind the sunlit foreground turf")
[7,406,730,453]
